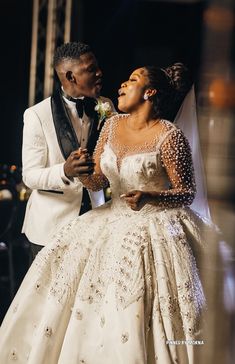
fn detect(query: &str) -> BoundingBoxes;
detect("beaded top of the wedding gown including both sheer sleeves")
[83,115,195,207]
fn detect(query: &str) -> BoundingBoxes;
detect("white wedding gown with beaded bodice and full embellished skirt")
[0,116,209,364]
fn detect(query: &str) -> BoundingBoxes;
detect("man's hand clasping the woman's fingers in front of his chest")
[64,148,95,178]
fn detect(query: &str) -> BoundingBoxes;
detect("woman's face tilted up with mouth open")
[118,68,149,113]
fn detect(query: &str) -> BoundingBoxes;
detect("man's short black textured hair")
[53,42,91,68]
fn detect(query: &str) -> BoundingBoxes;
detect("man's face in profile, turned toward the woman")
[67,52,102,97]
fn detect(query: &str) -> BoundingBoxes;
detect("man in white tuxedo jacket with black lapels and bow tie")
[22,42,115,257]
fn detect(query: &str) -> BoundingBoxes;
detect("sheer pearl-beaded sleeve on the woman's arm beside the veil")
[158,129,196,208]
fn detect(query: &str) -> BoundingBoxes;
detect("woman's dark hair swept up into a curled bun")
[144,63,192,121]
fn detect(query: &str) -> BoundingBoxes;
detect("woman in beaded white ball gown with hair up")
[0,64,209,364]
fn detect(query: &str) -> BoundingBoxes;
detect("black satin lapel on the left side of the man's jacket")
[51,90,80,159]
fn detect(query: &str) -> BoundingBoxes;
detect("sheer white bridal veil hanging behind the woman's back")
[174,86,211,220]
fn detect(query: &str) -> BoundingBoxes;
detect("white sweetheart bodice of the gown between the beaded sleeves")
[101,138,169,199]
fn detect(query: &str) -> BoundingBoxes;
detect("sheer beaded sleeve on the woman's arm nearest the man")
[76,118,111,191]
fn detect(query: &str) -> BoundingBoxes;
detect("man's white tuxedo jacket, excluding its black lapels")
[22,97,114,245]
